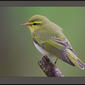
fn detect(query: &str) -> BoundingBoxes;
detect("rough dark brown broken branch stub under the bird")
[38,56,64,77]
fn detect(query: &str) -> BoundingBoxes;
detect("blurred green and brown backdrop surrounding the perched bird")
[0,7,85,77]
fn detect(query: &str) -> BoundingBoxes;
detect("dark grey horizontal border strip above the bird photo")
[0,1,85,6]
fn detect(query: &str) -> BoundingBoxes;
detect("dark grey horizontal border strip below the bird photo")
[0,77,85,84]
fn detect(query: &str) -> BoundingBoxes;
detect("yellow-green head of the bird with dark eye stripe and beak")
[21,15,49,32]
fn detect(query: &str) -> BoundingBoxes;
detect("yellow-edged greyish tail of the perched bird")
[66,49,85,70]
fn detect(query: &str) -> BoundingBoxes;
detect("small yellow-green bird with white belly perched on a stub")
[21,15,85,70]
